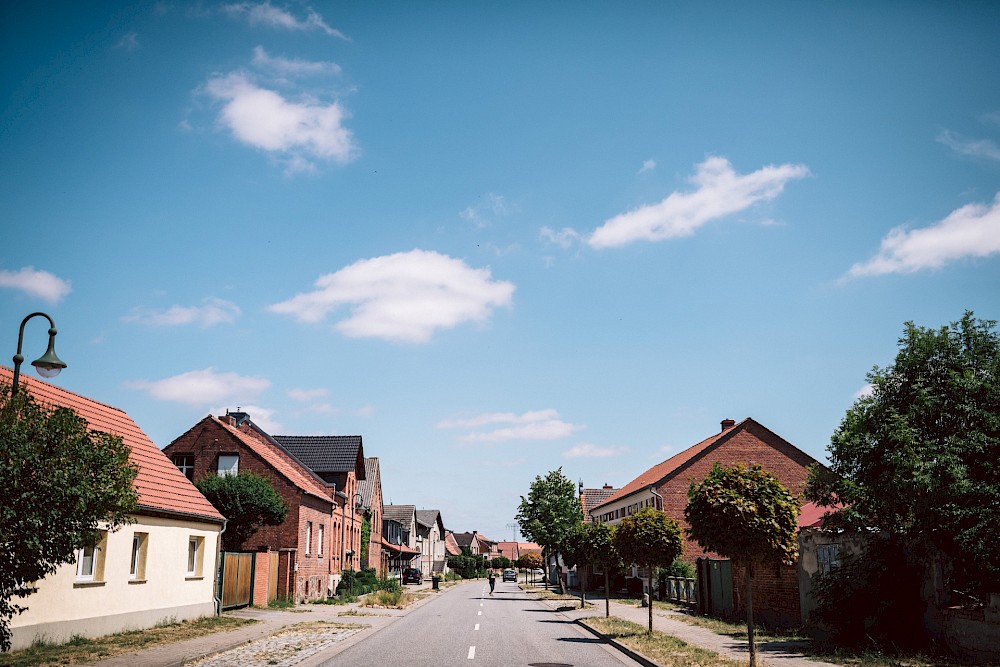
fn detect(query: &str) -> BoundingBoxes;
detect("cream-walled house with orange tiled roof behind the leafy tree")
[0,367,224,650]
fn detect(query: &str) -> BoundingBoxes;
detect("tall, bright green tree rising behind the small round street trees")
[516,468,583,594]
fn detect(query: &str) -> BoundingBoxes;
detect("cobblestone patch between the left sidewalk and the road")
[186,623,364,667]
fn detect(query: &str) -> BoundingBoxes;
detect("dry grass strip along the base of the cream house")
[0,616,257,667]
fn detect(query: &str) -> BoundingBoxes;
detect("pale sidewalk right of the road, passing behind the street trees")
[544,594,840,667]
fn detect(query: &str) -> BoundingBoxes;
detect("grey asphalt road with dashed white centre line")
[322,580,638,667]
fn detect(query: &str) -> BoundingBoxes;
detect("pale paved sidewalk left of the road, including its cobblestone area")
[90,582,446,667]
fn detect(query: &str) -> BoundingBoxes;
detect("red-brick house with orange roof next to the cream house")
[163,412,340,602]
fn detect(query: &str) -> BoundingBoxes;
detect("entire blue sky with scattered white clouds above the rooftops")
[0,2,1000,539]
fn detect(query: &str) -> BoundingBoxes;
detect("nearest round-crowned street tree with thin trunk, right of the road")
[684,463,799,667]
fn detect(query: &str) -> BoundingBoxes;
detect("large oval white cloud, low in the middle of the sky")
[269,250,514,343]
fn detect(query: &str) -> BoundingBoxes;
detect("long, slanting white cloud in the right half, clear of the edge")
[588,157,809,248]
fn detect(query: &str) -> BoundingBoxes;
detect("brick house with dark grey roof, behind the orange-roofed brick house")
[273,435,366,573]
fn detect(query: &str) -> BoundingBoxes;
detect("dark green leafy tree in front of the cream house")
[0,386,139,651]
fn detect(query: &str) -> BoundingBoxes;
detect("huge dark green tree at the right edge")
[806,312,1000,640]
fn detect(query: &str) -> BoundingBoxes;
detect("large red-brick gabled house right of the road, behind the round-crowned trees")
[590,418,821,625]
